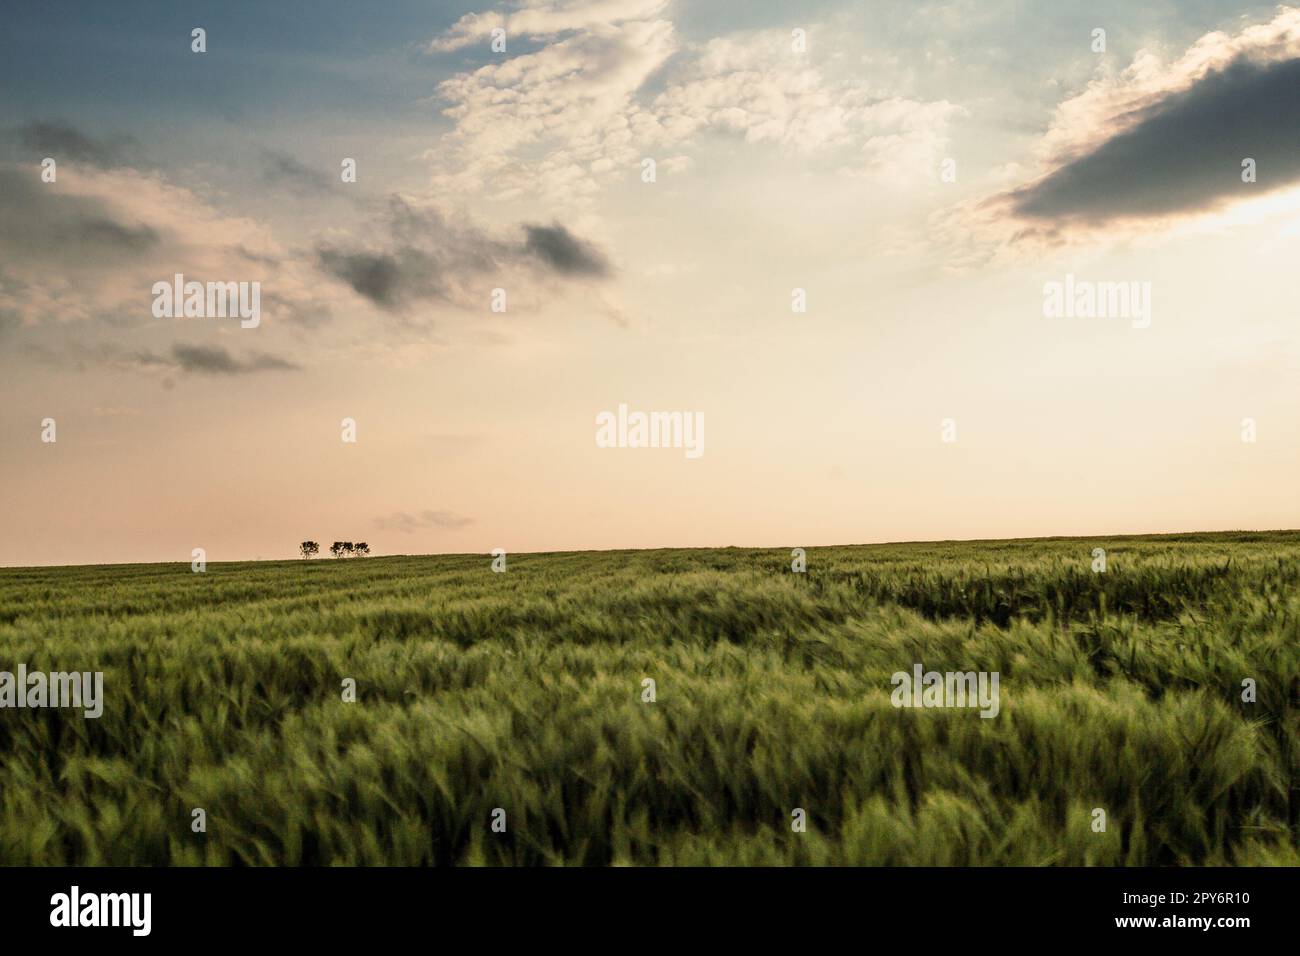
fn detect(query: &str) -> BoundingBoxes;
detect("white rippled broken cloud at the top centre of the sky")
[426,13,961,206]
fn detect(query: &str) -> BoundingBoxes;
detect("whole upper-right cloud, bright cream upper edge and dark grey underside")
[959,9,1300,245]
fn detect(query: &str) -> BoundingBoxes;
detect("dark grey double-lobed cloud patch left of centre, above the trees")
[316,198,610,312]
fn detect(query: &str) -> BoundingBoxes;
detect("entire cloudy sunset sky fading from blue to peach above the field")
[0,0,1300,566]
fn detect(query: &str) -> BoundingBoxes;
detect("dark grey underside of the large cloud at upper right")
[1005,57,1300,224]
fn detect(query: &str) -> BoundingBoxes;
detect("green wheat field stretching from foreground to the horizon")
[0,532,1300,866]
